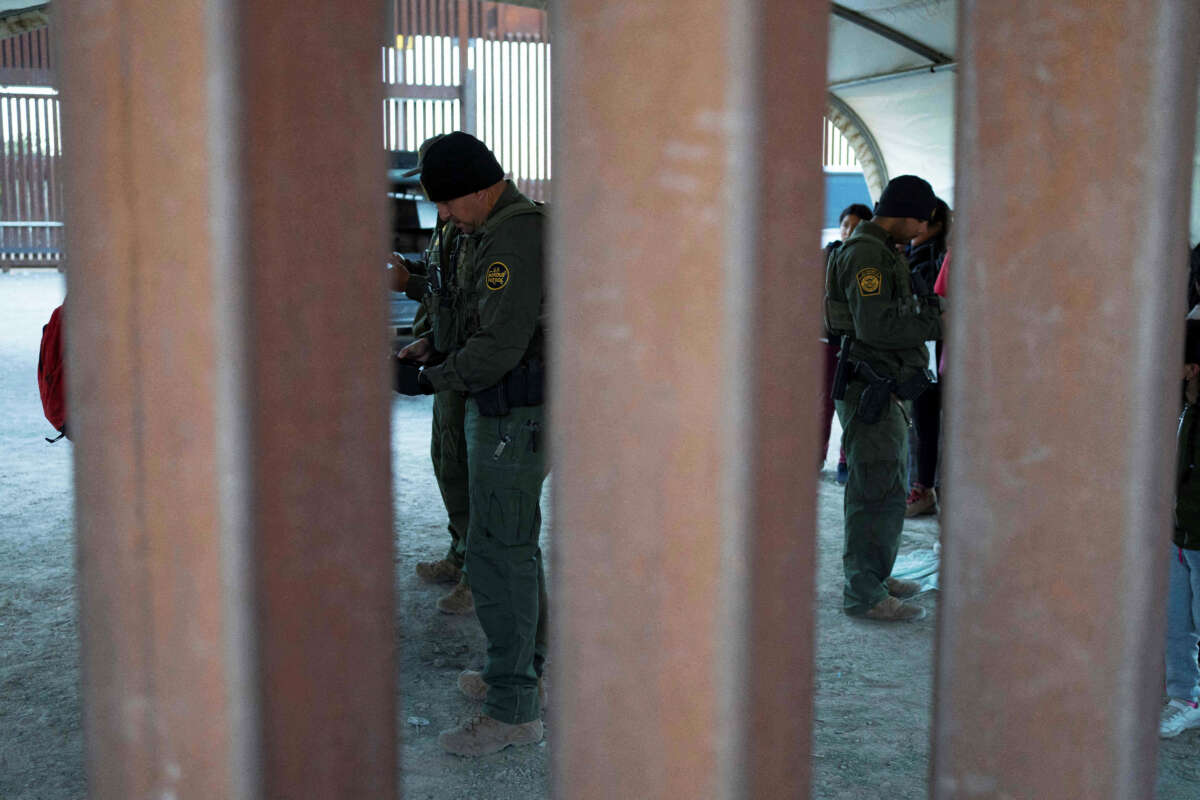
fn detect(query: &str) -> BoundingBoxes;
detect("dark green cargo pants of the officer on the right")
[834,380,908,614]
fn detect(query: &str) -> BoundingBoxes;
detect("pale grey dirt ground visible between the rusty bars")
[0,272,1200,800]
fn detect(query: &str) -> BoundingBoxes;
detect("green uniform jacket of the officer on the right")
[826,222,942,383]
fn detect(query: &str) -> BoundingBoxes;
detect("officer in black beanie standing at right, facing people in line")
[826,175,942,621]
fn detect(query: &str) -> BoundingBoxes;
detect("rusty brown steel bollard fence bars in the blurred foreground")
[60,0,1200,800]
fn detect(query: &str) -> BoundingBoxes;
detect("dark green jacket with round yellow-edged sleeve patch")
[425,181,545,392]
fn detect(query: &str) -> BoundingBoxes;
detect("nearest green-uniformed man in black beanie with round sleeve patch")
[396,133,547,756]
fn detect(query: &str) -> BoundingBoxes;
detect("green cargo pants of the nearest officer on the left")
[466,401,547,723]
